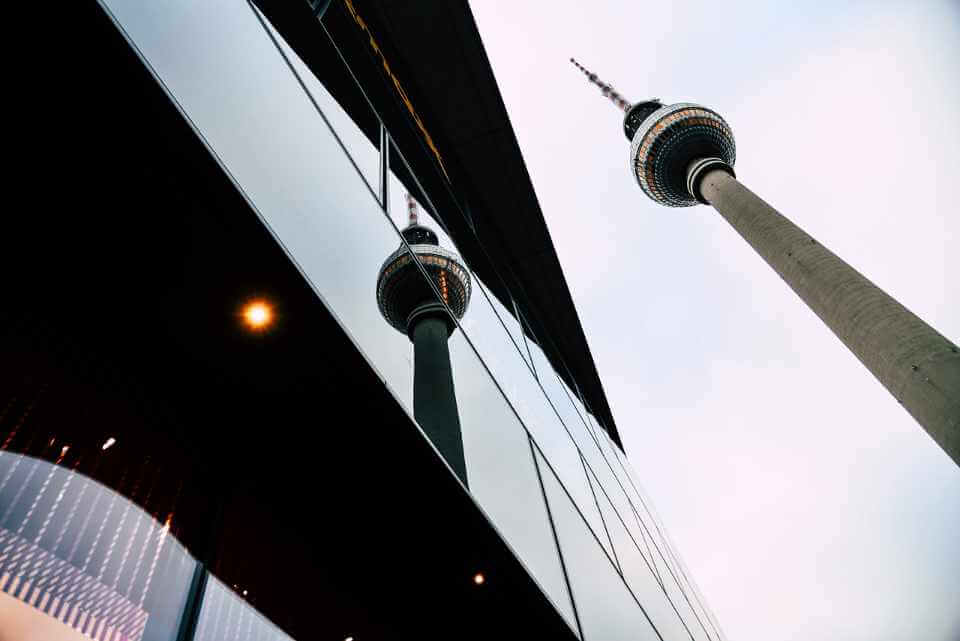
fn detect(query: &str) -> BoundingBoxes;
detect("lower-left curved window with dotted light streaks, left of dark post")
[0,450,197,641]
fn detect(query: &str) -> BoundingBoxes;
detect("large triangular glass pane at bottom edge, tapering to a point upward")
[537,452,660,641]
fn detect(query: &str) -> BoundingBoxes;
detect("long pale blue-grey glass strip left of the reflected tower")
[105,0,413,416]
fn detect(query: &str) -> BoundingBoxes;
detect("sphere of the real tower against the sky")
[624,101,737,207]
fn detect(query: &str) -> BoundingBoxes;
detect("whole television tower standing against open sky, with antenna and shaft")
[570,58,960,465]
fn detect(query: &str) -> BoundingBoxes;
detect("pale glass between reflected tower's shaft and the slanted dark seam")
[449,324,576,629]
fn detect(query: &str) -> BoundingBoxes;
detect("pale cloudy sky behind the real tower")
[471,0,960,641]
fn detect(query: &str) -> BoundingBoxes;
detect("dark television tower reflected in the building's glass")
[377,194,470,485]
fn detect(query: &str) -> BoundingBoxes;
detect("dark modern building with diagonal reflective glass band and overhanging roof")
[0,0,724,641]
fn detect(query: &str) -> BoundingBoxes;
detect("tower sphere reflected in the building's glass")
[377,224,470,335]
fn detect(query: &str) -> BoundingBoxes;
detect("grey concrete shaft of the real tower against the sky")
[698,168,960,465]
